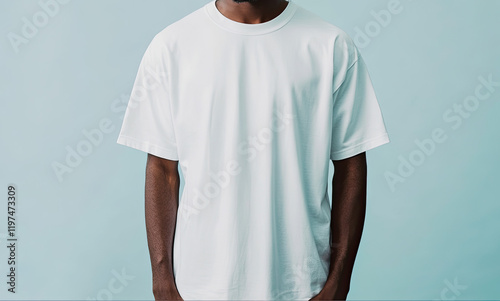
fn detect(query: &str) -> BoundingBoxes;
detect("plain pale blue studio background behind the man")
[0,0,500,300]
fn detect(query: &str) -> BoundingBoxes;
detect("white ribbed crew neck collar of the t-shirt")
[205,0,297,35]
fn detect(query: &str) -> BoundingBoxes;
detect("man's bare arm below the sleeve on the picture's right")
[311,152,367,300]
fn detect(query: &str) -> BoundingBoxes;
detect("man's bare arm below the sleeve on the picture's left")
[145,154,182,300]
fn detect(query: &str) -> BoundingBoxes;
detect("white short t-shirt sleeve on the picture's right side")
[330,46,390,160]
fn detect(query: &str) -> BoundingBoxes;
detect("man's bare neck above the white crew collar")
[215,0,288,24]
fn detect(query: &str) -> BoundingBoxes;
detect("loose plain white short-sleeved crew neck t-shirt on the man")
[118,0,389,300]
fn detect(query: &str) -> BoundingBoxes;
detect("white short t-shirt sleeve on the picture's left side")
[117,36,179,161]
